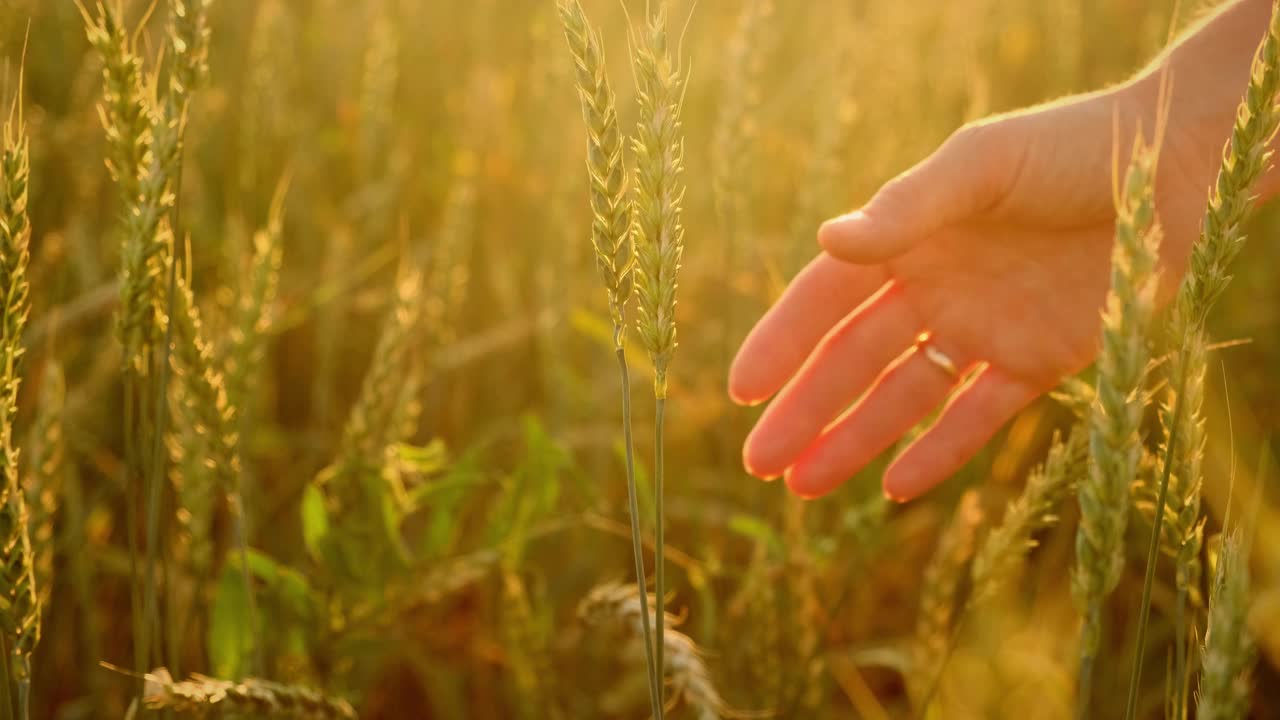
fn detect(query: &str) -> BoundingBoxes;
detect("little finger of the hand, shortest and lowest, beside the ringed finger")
[884,366,1041,502]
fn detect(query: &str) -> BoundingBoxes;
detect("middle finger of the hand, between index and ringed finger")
[742,282,919,478]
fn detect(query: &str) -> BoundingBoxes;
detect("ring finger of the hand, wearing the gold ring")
[786,338,959,497]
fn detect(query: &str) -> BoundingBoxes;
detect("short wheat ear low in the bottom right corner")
[1196,532,1257,720]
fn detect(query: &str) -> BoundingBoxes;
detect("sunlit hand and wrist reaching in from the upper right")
[728,0,1277,501]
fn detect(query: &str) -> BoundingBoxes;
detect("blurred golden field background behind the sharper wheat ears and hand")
[0,0,1280,719]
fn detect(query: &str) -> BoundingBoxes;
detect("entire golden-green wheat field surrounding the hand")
[0,0,1280,720]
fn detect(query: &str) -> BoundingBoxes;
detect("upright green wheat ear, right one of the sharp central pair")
[632,5,685,398]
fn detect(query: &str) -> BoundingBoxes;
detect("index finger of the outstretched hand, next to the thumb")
[728,252,887,405]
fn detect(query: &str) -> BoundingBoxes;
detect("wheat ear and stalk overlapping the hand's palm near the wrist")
[1071,130,1161,716]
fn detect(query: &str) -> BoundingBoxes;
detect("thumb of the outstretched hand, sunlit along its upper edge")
[818,126,1002,264]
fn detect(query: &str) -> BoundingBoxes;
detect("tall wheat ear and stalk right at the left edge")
[0,87,40,717]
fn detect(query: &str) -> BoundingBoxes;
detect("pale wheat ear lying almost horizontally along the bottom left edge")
[142,667,357,720]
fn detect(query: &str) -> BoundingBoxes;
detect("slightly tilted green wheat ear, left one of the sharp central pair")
[559,0,634,347]
